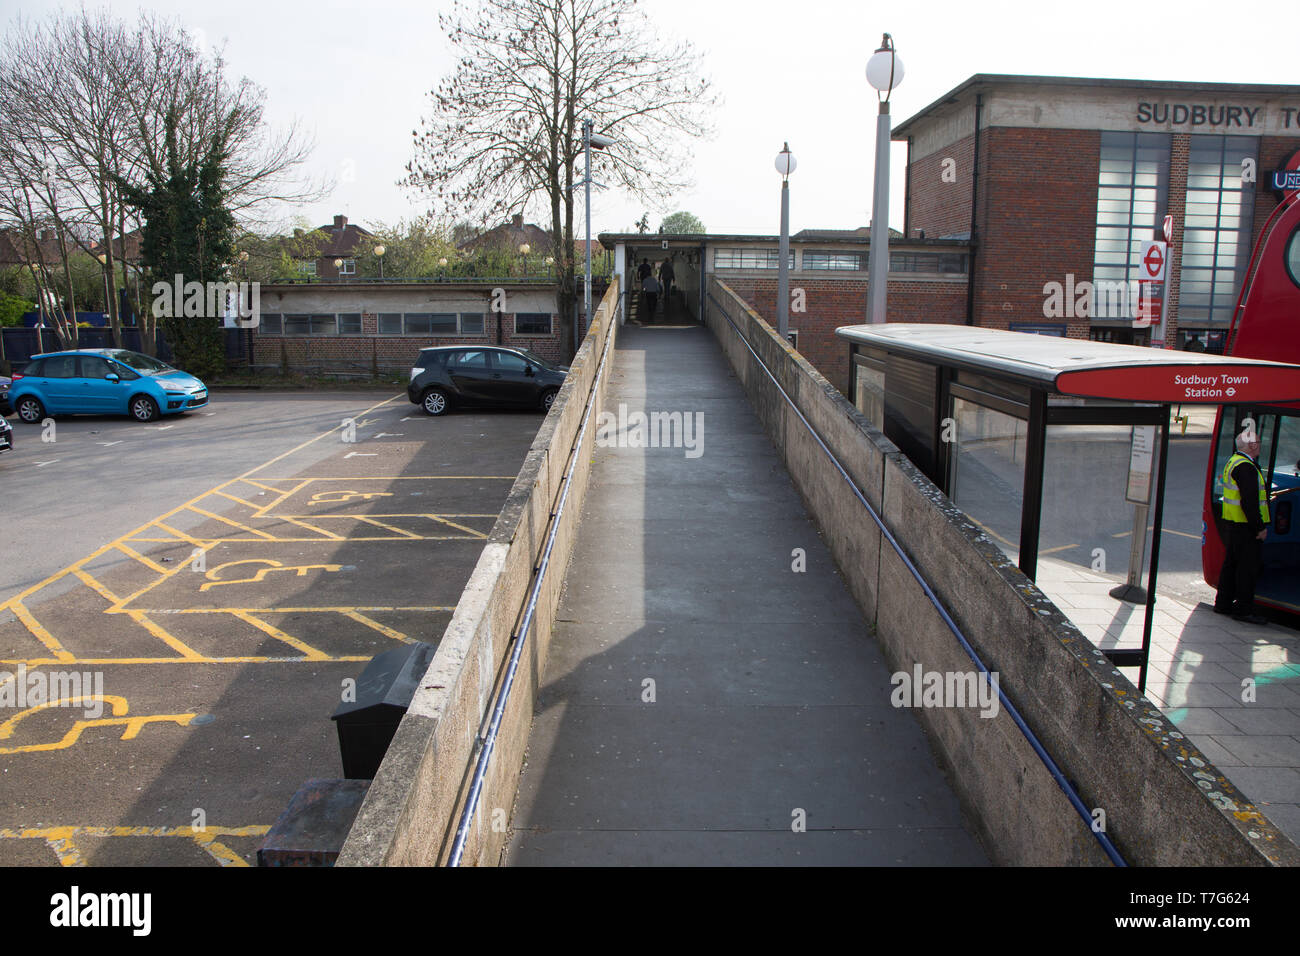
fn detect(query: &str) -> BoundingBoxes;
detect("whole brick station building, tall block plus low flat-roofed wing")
[601,74,1300,392]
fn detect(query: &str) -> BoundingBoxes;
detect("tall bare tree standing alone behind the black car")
[403,0,715,352]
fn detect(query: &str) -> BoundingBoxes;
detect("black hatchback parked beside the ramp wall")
[407,345,568,415]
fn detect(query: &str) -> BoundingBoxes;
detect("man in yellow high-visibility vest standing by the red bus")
[1214,425,1269,624]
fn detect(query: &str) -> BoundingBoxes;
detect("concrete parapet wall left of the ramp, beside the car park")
[338,282,619,866]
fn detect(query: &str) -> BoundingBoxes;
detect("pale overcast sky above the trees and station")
[0,0,1300,234]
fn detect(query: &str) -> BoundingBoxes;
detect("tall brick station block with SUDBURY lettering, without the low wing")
[891,74,1300,350]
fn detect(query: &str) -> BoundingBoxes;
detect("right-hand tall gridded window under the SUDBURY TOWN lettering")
[1178,135,1260,325]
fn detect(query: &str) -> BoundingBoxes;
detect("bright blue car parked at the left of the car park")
[9,349,208,424]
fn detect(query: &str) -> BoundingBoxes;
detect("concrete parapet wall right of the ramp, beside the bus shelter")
[705,280,1300,866]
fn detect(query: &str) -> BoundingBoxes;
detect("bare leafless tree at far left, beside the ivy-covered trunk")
[0,8,322,351]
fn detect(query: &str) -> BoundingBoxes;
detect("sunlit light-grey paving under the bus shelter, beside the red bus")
[1037,558,1300,843]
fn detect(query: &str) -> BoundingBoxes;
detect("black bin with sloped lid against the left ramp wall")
[330,644,434,780]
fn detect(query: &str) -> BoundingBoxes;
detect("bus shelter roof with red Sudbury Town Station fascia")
[835,323,1300,405]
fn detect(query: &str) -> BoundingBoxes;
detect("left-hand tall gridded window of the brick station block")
[1092,133,1170,320]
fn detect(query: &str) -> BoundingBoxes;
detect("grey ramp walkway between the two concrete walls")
[504,326,988,865]
